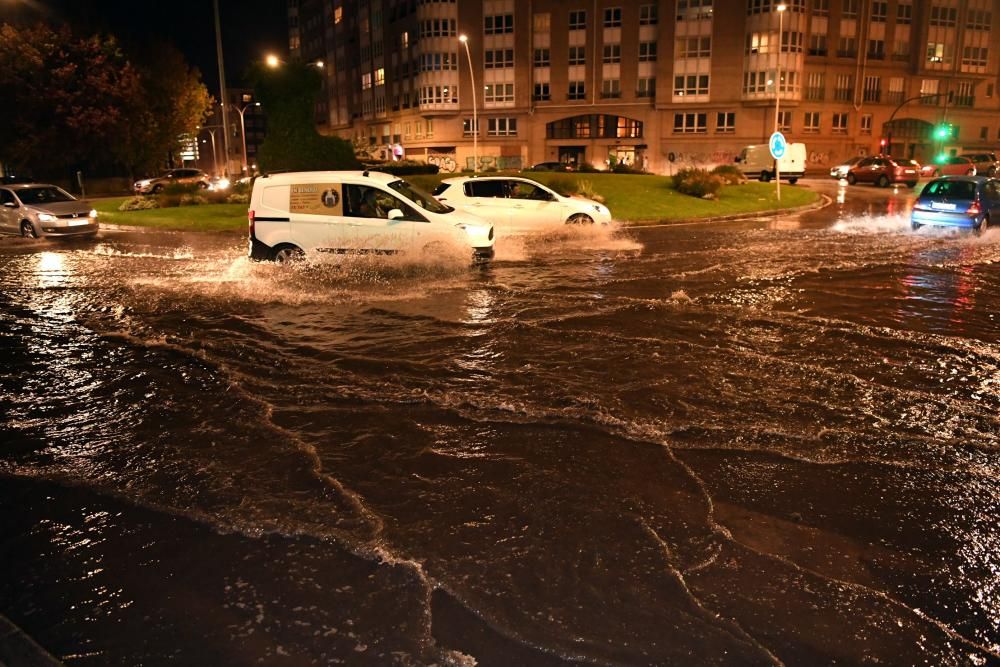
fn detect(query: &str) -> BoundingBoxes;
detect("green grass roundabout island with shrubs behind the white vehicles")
[95,172,819,232]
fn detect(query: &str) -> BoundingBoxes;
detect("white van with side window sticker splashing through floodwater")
[247,171,493,262]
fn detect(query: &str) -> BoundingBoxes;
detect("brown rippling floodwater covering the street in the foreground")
[0,181,1000,666]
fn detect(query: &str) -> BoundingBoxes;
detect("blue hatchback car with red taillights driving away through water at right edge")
[910,176,1000,232]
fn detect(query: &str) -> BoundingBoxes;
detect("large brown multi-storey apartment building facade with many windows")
[289,0,1000,173]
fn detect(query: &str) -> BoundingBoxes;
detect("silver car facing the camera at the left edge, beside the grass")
[0,183,98,239]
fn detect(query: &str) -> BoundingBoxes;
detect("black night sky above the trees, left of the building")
[0,0,288,97]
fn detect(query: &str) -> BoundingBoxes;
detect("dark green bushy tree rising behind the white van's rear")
[250,63,360,173]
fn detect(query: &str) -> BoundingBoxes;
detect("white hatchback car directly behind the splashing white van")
[434,176,611,234]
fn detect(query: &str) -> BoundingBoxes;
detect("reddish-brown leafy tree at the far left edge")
[0,24,143,179]
